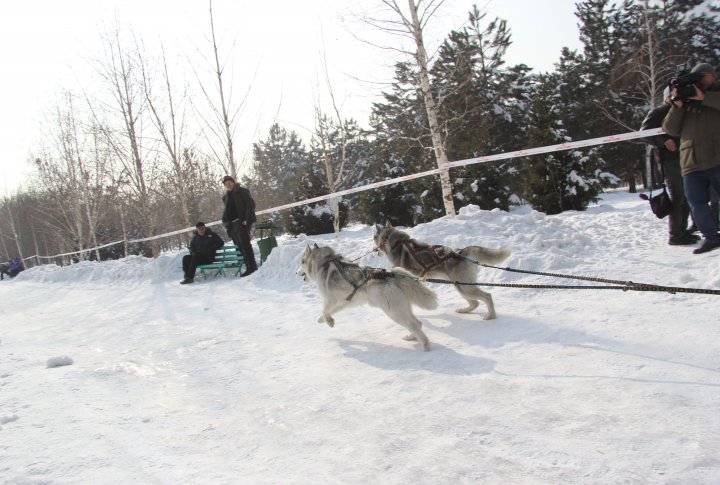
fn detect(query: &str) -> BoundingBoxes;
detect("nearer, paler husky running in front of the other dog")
[297,244,437,350]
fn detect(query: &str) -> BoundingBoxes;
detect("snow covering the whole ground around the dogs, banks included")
[0,192,720,484]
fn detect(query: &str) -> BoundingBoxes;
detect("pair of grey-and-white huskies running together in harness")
[297,223,510,350]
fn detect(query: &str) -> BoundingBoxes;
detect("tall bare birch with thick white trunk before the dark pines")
[363,0,455,217]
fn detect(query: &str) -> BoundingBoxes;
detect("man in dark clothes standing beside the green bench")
[222,175,257,276]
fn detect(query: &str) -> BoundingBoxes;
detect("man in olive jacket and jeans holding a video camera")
[663,63,720,254]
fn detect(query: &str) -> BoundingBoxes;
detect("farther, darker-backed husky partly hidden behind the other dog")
[375,222,510,320]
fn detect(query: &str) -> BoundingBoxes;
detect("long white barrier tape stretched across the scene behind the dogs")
[29,128,663,259]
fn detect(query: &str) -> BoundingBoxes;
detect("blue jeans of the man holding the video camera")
[683,165,720,242]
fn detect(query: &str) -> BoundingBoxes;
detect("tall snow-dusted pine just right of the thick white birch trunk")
[433,7,530,209]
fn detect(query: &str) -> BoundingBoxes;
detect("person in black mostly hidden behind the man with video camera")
[640,93,700,246]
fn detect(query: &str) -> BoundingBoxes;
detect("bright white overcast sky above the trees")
[0,0,580,193]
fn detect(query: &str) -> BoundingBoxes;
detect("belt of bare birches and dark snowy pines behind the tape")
[0,0,720,259]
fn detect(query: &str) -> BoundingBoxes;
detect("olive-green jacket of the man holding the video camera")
[663,82,720,175]
